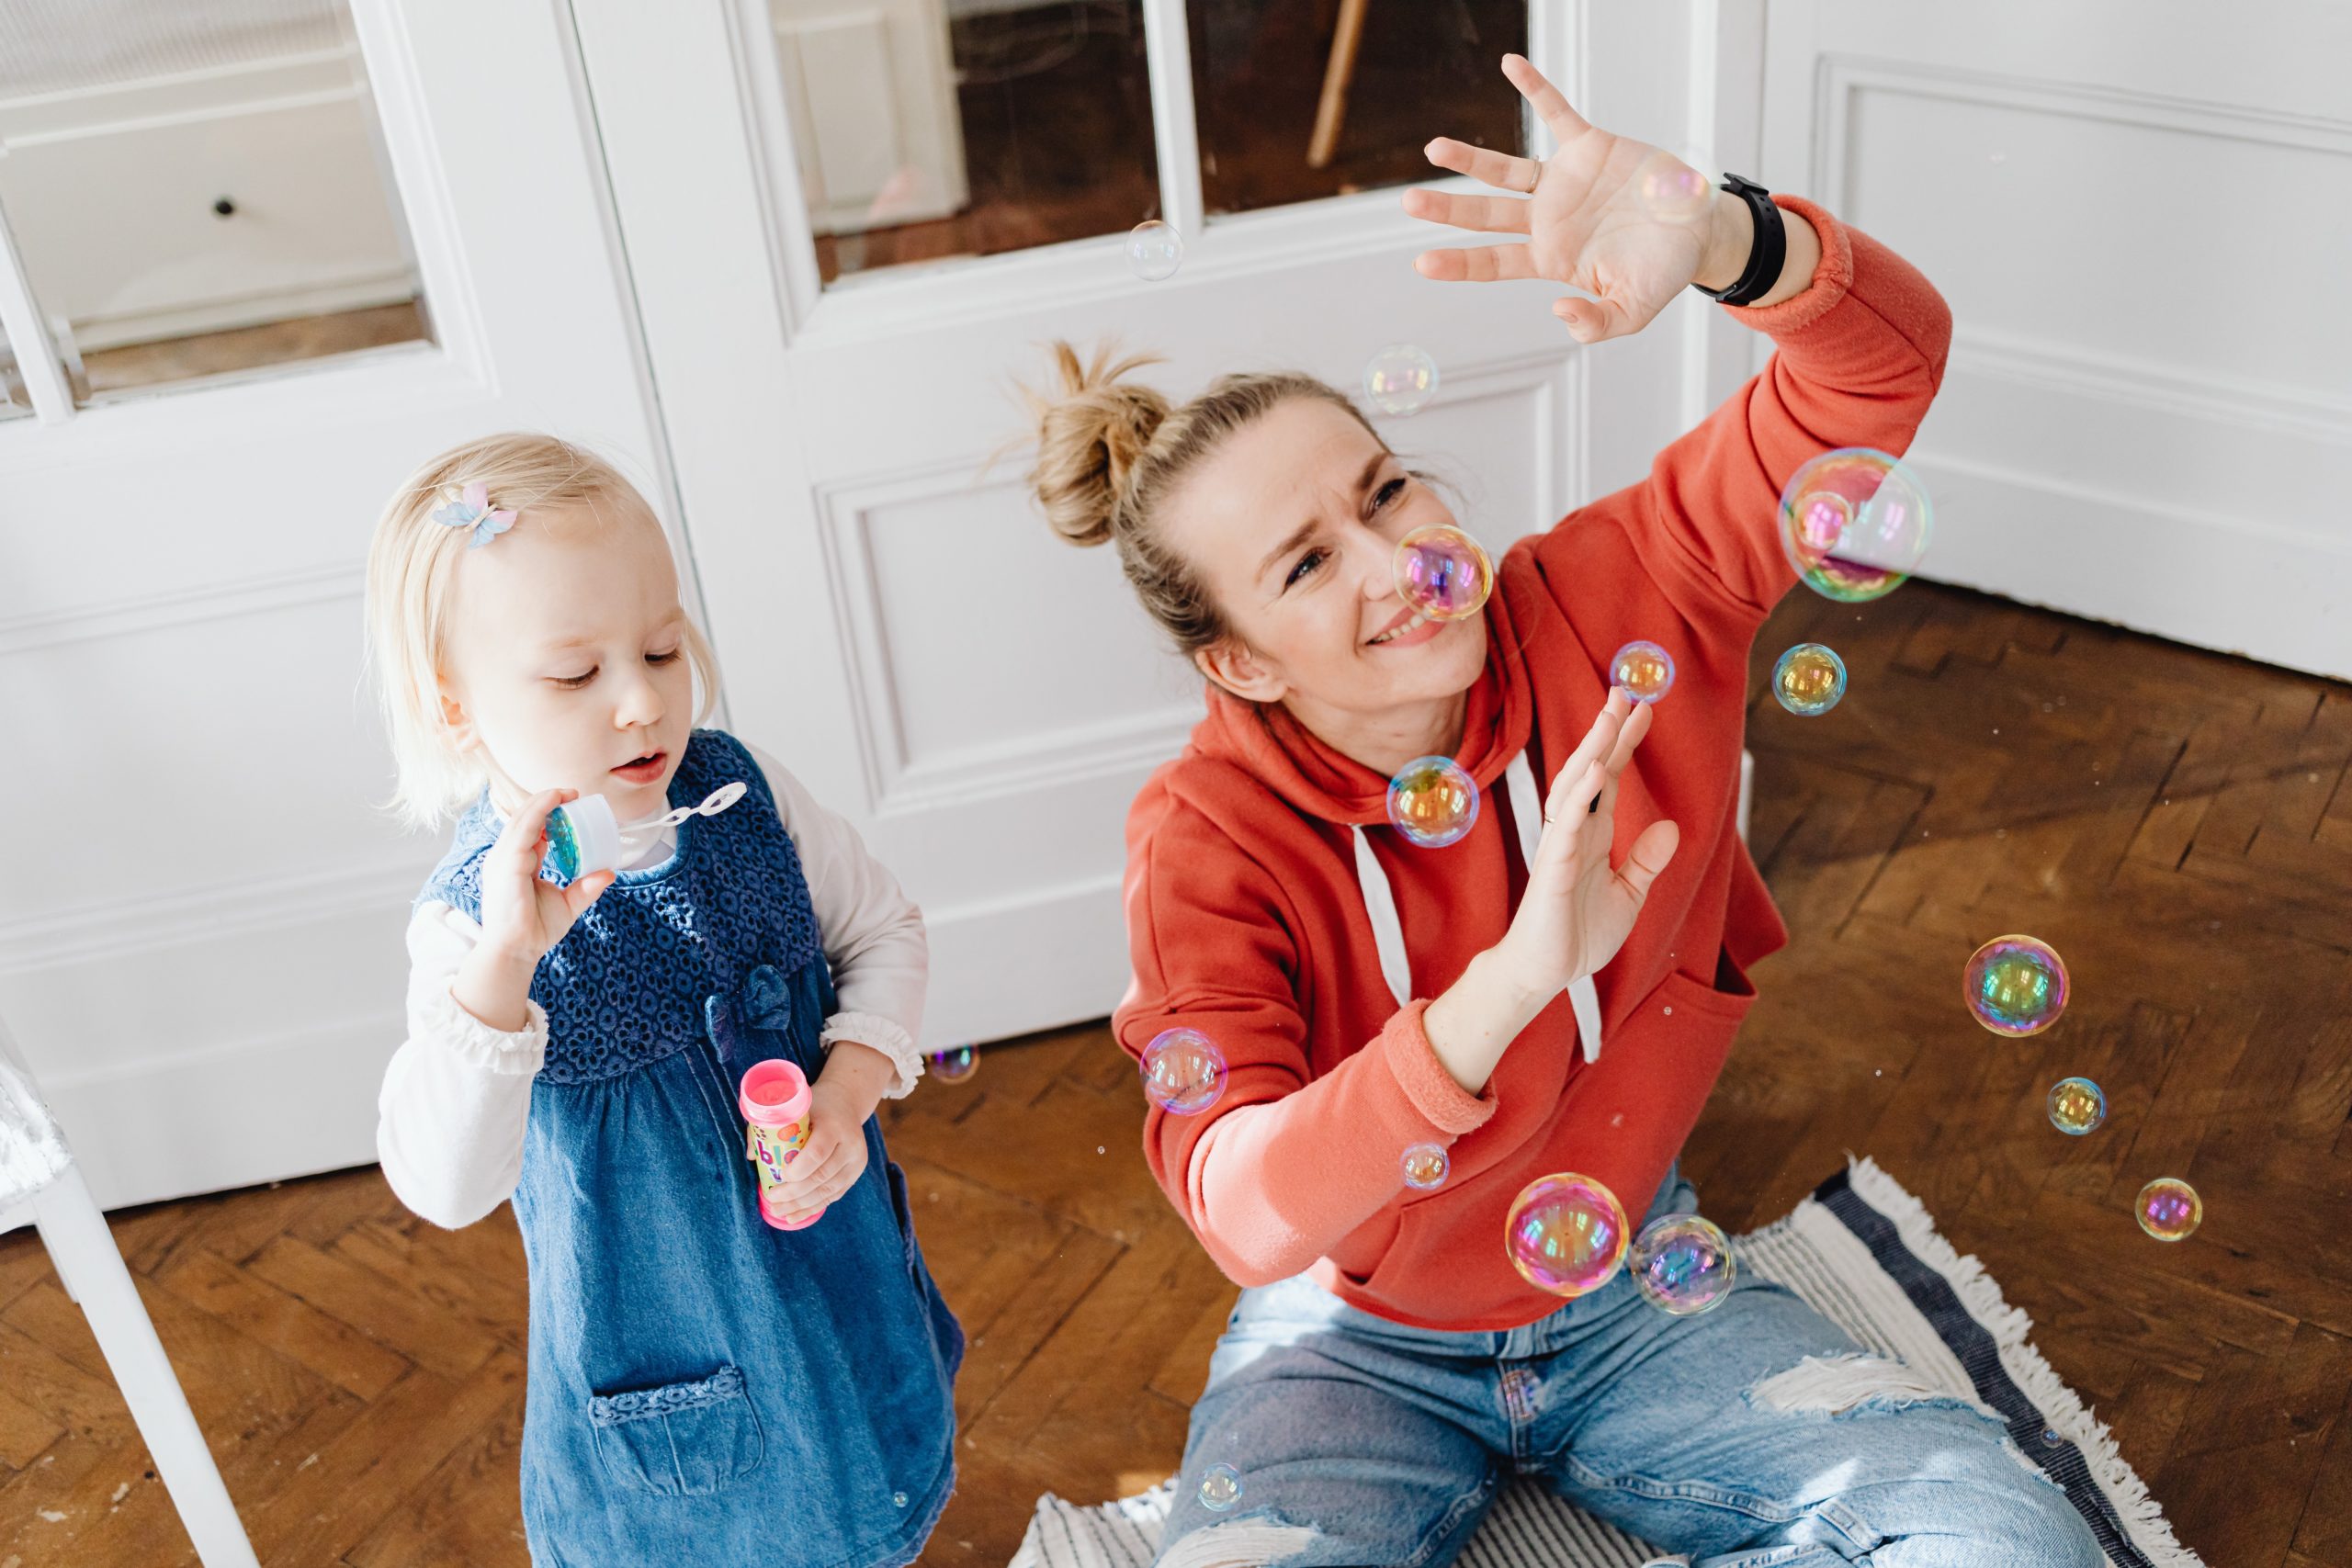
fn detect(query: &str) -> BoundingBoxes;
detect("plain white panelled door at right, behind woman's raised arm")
[1764,0,2352,677]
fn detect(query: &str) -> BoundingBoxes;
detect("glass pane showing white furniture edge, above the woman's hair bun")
[769,0,1159,282]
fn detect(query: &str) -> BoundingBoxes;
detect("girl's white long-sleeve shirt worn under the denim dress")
[377,748,932,1229]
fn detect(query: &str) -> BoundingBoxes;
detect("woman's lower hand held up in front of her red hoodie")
[1494,689,1681,997]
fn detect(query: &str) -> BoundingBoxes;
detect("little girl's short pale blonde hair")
[367,433,719,828]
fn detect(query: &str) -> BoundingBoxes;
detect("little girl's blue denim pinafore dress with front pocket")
[419,731,965,1568]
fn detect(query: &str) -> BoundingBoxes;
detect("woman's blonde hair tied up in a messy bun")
[1023,341,1387,659]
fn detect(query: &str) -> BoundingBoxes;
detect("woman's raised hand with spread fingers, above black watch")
[1404,54,1746,344]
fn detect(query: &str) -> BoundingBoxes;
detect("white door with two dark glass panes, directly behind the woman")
[574,0,1698,1043]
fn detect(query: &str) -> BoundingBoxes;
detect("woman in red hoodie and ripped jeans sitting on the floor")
[1033,56,2100,1568]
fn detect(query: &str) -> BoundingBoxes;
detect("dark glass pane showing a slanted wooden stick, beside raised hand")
[1185,0,1526,214]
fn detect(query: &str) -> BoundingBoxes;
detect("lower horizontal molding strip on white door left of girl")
[0,861,418,976]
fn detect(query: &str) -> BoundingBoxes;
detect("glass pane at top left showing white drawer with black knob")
[0,0,430,398]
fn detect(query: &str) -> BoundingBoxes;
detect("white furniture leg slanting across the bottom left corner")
[33,1166,259,1568]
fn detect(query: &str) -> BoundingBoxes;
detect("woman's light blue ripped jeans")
[1159,1173,2103,1568]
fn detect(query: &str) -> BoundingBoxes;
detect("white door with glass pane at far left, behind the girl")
[0,0,668,1203]
